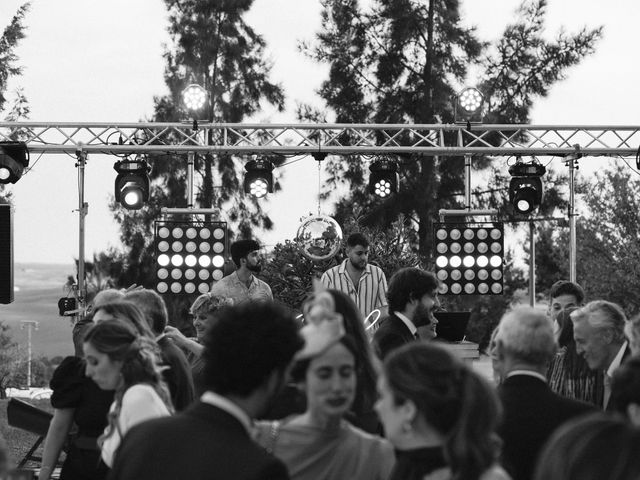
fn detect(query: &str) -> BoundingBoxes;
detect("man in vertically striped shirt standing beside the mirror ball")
[320,233,387,319]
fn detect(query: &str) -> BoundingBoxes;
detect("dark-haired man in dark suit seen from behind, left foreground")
[109,302,303,480]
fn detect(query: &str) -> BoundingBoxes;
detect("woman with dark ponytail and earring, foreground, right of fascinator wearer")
[376,342,509,480]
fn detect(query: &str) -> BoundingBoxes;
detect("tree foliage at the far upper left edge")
[0,2,31,203]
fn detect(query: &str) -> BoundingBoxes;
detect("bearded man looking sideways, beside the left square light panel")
[209,240,273,305]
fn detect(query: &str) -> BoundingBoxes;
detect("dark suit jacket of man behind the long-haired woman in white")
[158,337,195,412]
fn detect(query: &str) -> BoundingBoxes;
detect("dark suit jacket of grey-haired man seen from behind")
[498,375,595,480]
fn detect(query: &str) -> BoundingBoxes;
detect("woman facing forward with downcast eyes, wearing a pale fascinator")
[256,284,395,480]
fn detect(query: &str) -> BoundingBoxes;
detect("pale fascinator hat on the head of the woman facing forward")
[295,279,345,360]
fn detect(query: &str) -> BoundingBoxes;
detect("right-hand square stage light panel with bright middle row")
[434,222,504,295]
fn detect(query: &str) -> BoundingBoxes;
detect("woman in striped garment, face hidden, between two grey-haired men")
[547,307,604,406]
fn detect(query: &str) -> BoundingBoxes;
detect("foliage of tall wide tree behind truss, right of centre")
[303,0,601,257]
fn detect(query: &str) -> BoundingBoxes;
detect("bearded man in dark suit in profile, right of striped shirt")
[373,268,440,359]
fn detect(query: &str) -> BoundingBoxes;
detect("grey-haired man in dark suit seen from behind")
[494,307,594,480]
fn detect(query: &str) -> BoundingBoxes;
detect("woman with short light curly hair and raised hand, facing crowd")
[164,293,233,397]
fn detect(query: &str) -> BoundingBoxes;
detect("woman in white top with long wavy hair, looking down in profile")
[82,319,173,467]
